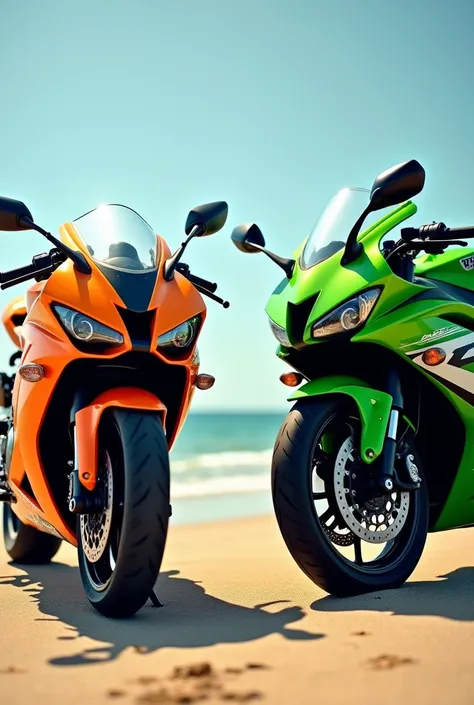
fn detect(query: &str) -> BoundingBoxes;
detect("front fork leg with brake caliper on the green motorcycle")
[378,369,420,492]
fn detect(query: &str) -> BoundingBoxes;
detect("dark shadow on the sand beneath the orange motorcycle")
[0,562,324,666]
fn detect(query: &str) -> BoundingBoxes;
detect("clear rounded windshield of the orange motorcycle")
[73,205,158,272]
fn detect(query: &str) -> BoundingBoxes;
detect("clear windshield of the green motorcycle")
[301,188,393,269]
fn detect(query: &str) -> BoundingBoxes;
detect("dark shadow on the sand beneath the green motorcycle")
[311,566,474,622]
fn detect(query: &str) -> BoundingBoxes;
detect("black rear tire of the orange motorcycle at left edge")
[3,504,62,565]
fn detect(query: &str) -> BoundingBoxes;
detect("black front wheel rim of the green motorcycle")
[308,413,419,574]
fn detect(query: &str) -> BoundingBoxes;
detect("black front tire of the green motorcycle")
[272,395,429,597]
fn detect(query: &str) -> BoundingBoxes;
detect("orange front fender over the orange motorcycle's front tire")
[74,387,166,492]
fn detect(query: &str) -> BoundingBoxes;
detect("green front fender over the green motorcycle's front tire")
[288,375,392,463]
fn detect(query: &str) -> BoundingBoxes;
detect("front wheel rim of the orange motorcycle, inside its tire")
[79,425,124,592]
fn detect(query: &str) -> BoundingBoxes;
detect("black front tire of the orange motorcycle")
[77,409,170,617]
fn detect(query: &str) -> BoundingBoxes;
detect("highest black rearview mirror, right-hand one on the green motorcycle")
[370,159,425,211]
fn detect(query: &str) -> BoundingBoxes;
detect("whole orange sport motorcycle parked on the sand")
[0,198,229,617]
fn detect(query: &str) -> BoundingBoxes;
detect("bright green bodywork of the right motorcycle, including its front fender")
[266,195,474,531]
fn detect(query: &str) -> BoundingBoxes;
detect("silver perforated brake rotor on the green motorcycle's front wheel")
[334,436,410,545]
